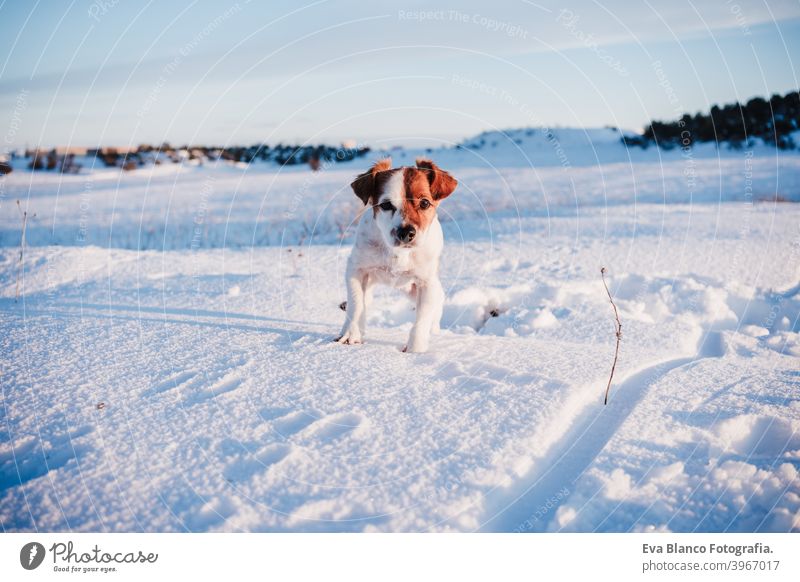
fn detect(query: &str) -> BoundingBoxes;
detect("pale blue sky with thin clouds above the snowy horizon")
[0,0,800,148]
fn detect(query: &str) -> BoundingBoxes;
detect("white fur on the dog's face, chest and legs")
[337,160,457,352]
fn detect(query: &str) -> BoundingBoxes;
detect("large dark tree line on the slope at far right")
[622,91,800,149]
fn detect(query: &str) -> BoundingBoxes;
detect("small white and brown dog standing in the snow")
[336,159,458,352]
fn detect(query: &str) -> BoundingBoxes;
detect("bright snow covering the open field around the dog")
[0,135,800,532]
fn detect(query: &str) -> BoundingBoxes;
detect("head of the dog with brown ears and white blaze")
[351,158,458,247]
